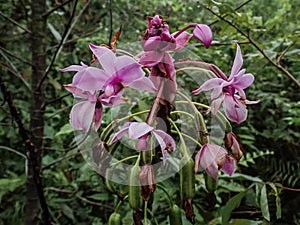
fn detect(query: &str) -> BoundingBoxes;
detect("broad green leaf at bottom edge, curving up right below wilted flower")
[221,189,249,225]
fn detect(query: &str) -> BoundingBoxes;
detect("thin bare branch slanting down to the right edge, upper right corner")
[203,5,300,87]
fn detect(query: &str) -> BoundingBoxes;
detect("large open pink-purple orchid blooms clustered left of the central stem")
[61,44,156,132]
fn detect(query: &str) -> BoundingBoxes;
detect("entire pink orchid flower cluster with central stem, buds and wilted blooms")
[61,15,258,222]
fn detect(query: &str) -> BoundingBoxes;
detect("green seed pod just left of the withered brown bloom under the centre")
[128,166,143,210]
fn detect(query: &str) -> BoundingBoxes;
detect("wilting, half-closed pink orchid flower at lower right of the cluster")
[195,144,234,180]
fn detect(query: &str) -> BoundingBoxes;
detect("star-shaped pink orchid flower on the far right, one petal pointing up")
[192,44,259,124]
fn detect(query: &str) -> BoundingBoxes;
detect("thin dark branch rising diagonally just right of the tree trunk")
[38,0,90,89]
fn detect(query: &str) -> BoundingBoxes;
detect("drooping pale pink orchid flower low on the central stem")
[110,122,176,165]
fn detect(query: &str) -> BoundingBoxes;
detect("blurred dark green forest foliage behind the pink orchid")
[0,0,300,225]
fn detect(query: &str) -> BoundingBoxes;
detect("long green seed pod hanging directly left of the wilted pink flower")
[179,158,195,200]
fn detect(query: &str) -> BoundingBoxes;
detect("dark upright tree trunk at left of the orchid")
[25,0,49,225]
